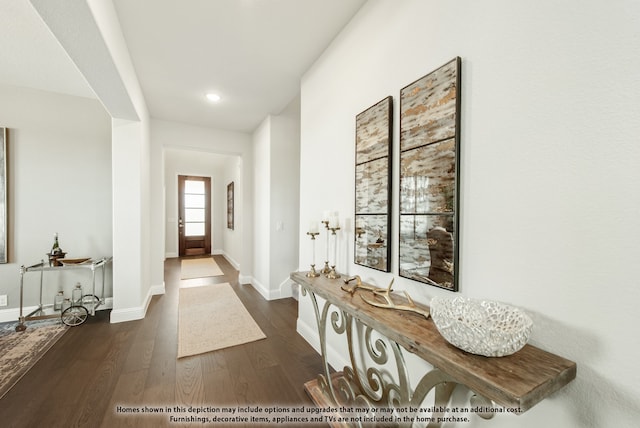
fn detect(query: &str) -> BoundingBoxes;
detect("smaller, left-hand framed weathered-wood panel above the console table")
[354,97,393,272]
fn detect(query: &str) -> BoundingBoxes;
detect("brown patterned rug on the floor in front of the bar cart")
[0,324,68,398]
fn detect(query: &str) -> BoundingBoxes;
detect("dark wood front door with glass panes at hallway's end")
[178,175,211,257]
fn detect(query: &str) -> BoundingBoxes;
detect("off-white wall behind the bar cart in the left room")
[0,85,112,321]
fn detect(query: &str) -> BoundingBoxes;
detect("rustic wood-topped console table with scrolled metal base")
[290,272,576,427]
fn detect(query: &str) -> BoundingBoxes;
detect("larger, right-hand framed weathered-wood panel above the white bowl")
[399,57,461,291]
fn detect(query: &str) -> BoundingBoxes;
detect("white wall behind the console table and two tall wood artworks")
[299,0,640,428]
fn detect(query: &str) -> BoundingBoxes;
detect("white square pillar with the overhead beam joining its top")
[31,0,156,322]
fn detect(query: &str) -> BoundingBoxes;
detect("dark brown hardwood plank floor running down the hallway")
[0,256,322,427]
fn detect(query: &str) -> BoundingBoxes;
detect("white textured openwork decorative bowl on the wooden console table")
[430,297,533,357]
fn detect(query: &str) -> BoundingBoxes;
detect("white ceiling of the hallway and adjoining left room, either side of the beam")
[0,0,366,132]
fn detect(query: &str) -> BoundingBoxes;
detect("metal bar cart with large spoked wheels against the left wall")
[16,257,113,331]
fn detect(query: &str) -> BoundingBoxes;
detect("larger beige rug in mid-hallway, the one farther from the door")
[178,282,266,358]
